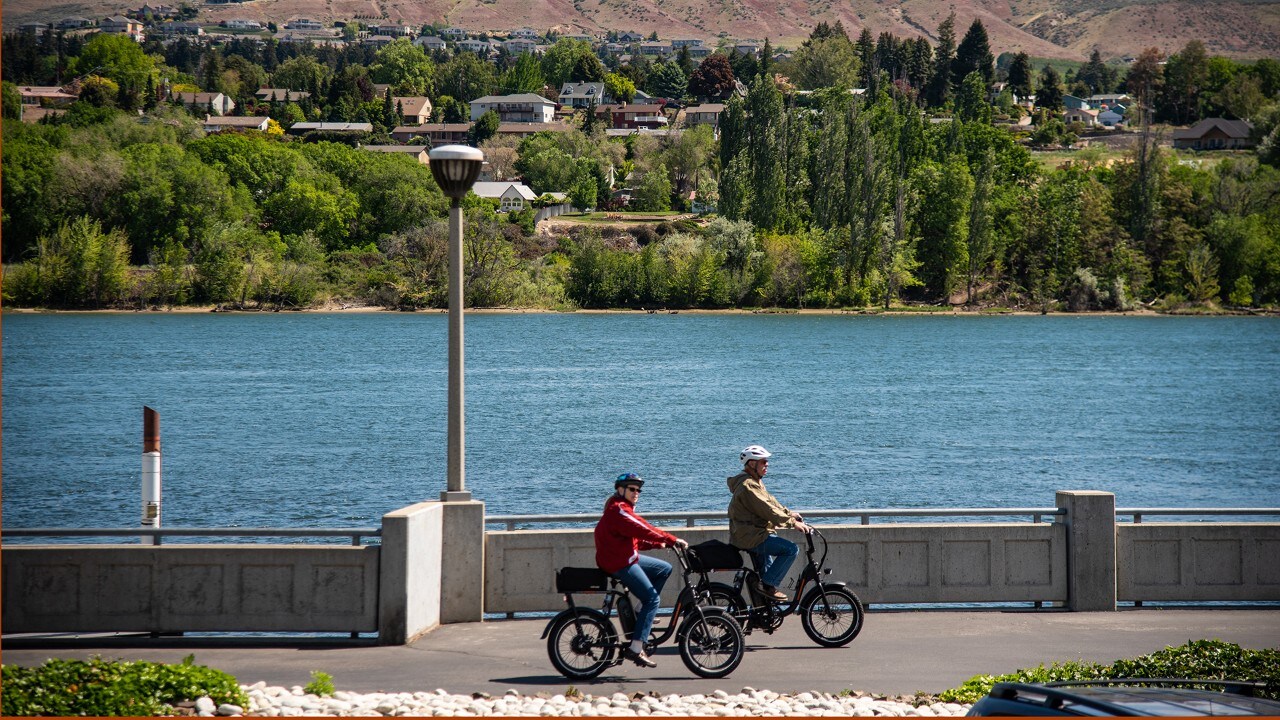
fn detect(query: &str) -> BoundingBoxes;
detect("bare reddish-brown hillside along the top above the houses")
[3,0,1280,60]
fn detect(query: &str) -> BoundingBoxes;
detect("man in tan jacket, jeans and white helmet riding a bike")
[728,445,809,600]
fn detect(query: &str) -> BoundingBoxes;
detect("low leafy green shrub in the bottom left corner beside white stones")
[0,656,248,716]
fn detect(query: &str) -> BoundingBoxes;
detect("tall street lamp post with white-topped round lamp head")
[429,145,484,502]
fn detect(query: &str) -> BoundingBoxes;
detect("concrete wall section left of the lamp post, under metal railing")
[3,544,379,633]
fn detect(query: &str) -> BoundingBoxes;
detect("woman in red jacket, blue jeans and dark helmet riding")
[595,473,689,667]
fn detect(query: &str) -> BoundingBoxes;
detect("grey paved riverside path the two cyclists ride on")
[0,609,1280,696]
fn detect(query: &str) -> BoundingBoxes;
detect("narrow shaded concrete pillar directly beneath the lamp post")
[440,500,484,623]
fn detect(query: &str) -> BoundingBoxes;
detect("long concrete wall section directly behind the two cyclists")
[484,523,1068,612]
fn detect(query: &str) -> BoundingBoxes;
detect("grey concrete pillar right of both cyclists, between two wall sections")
[1056,491,1116,611]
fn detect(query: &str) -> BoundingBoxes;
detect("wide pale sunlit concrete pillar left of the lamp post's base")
[378,502,445,644]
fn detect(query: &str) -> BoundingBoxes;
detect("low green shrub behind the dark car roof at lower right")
[938,641,1280,702]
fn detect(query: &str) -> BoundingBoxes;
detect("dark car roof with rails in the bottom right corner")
[969,680,1280,717]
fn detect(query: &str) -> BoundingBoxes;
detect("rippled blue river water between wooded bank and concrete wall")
[3,313,1280,528]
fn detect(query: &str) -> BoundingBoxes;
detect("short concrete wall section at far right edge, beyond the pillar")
[1116,523,1280,601]
